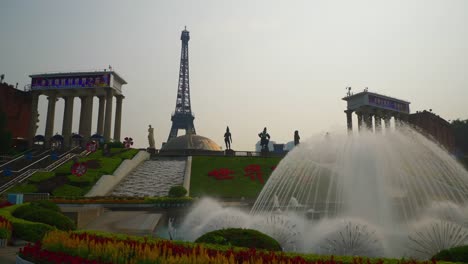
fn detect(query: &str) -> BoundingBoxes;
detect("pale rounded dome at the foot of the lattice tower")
[161,134,222,152]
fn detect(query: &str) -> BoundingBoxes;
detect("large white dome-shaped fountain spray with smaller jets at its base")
[176,126,468,258]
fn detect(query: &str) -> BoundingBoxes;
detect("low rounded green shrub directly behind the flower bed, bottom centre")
[195,228,281,251]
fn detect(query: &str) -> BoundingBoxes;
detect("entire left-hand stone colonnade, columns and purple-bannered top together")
[29,70,127,147]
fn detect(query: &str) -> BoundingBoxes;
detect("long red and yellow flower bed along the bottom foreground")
[20,231,442,264]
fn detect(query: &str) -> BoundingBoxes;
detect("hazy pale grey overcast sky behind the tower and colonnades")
[0,0,468,150]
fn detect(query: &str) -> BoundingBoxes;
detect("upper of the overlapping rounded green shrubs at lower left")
[13,205,76,230]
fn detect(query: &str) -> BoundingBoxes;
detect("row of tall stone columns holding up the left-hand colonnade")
[29,88,125,147]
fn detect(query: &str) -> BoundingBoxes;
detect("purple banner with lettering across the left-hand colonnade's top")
[31,74,110,89]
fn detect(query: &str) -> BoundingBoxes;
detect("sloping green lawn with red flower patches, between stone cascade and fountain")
[190,157,281,199]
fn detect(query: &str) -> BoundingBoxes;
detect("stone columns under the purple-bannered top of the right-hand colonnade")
[344,109,409,132]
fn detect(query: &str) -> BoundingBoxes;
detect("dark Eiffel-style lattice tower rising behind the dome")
[167,28,196,142]
